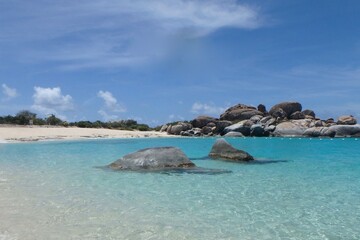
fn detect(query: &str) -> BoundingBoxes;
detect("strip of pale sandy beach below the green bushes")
[0,125,171,143]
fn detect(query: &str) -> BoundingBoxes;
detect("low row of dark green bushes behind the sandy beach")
[0,110,152,131]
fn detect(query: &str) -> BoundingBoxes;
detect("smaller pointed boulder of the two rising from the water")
[209,138,254,162]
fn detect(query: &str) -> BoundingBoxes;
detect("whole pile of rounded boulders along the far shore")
[160,102,360,137]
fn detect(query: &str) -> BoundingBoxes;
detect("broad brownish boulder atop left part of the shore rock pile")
[220,104,264,122]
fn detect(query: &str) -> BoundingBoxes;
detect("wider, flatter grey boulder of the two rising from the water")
[108,147,196,171]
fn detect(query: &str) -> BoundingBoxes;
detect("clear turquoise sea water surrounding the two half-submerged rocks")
[0,138,360,240]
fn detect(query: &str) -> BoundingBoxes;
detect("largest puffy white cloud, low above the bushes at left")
[32,87,74,119]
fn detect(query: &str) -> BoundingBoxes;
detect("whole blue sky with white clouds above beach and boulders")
[0,0,360,126]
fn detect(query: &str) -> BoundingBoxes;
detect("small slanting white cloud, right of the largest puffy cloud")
[97,90,127,121]
